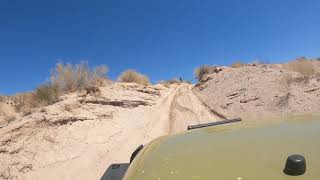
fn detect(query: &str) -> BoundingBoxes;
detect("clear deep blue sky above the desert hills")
[0,0,320,94]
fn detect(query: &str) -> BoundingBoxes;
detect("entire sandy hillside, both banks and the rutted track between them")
[0,59,320,179]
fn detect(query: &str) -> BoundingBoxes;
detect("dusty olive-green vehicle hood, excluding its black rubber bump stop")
[124,115,320,180]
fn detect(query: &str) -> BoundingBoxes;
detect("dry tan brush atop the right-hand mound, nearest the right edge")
[282,58,315,77]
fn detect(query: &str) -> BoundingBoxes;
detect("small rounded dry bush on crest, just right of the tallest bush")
[118,69,151,86]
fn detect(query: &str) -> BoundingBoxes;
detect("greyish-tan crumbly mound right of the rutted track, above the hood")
[194,65,320,118]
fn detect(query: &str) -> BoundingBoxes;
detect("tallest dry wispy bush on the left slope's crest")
[51,61,109,92]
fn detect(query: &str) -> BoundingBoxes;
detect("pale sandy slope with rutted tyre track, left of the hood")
[0,83,219,180]
